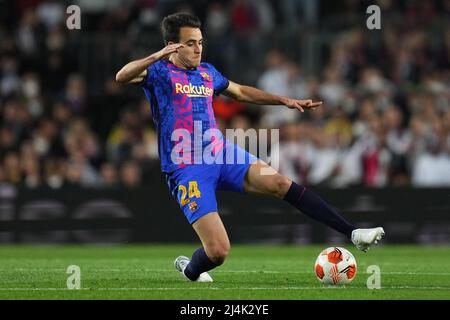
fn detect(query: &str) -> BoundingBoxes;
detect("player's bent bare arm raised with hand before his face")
[116,43,184,83]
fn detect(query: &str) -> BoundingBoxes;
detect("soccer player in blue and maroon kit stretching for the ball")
[116,13,384,282]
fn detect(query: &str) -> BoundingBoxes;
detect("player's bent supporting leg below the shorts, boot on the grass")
[174,212,230,282]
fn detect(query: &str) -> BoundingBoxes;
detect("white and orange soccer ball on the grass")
[314,247,356,285]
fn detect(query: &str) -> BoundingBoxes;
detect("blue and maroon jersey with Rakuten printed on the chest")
[141,60,229,172]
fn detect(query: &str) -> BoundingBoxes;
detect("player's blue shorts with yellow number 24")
[166,141,258,224]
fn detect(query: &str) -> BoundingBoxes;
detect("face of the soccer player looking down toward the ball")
[178,27,203,67]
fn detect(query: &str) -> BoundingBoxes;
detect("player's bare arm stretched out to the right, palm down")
[223,81,322,112]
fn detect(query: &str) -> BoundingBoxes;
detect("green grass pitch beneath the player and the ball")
[0,244,450,300]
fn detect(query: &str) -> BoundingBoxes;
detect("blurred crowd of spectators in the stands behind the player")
[0,0,450,188]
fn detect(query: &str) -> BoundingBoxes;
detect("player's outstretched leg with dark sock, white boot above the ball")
[244,160,384,252]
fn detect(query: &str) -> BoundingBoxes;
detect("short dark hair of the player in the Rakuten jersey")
[161,12,202,44]
